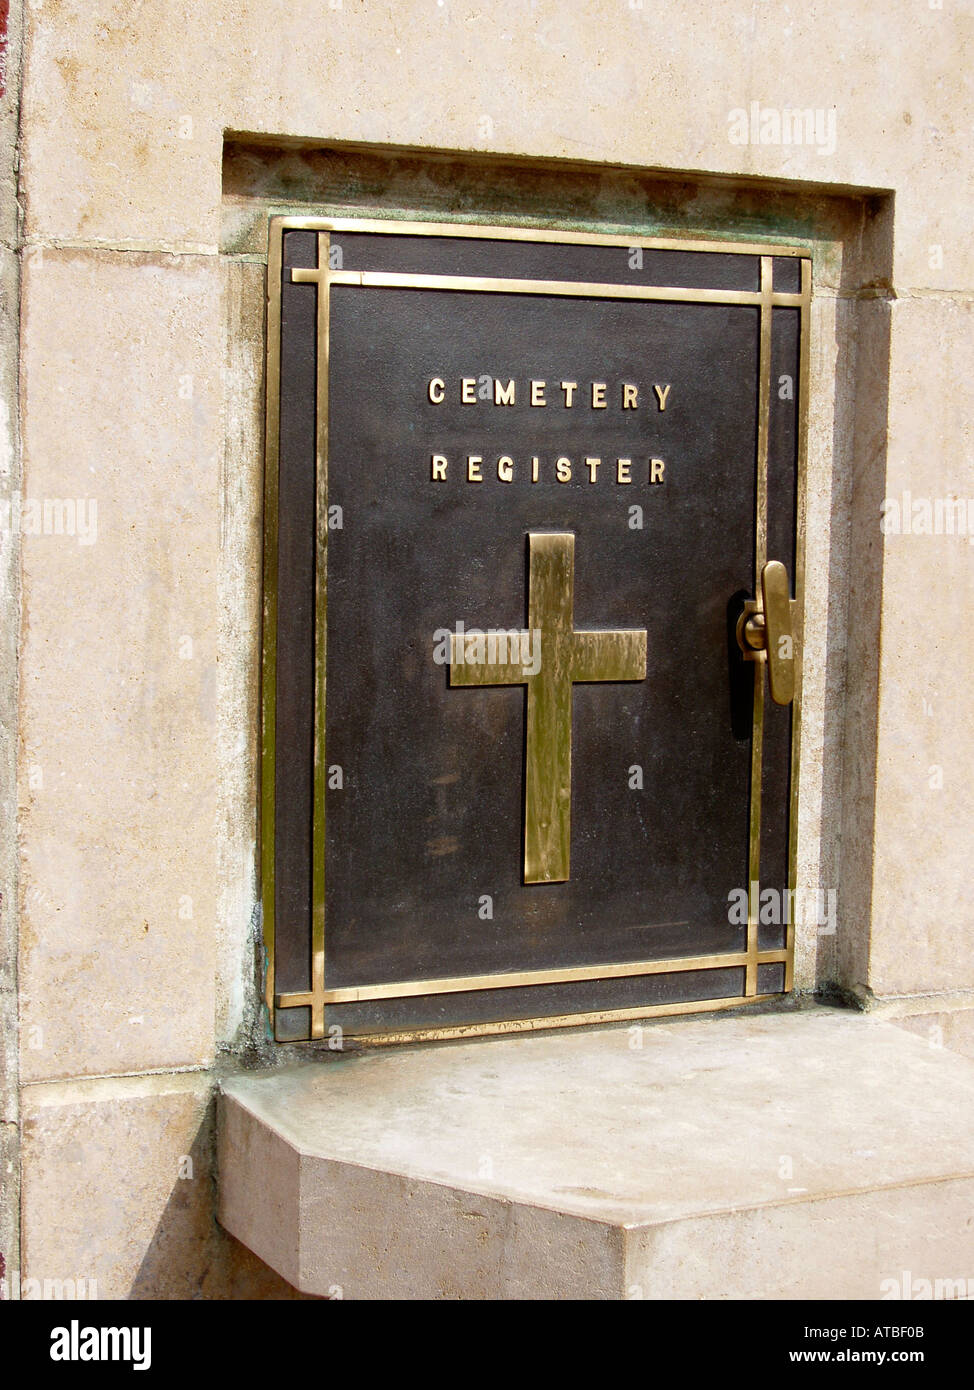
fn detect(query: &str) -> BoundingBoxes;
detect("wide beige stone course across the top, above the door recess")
[13,0,974,288]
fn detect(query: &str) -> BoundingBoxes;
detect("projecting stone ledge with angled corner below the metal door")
[220,1009,974,1298]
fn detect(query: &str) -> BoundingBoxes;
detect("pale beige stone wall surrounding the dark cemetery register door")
[0,0,974,1297]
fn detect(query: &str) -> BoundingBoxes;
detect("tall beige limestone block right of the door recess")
[853,297,974,995]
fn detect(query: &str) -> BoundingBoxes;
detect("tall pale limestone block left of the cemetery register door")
[19,252,221,1080]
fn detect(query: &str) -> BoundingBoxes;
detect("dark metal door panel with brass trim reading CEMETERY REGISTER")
[261,220,809,1038]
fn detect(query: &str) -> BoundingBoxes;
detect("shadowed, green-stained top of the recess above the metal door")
[221,146,883,293]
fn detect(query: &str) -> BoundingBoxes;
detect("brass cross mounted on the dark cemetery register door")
[450,531,646,883]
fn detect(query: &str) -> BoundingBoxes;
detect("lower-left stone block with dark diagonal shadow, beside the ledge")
[21,1073,311,1298]
